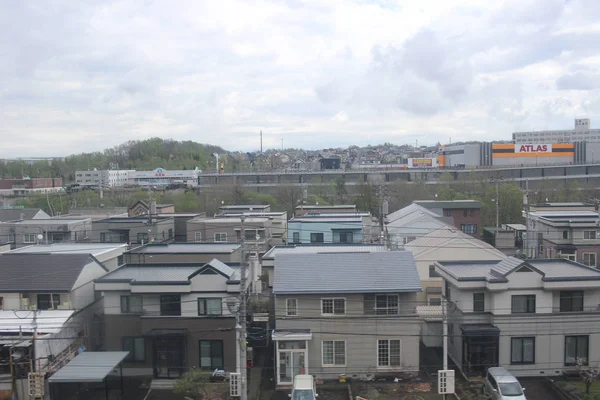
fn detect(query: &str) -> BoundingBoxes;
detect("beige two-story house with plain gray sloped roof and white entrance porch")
[272,251,421,387]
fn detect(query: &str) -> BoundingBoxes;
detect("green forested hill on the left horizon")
[0,138,227,182]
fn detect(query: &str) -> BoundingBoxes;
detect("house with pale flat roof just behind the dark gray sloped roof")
[10,243,127,271]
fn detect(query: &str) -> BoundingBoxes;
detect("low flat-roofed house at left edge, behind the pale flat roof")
[0,218,92,248]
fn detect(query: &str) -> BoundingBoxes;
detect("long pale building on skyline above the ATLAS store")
[513,118,600,144]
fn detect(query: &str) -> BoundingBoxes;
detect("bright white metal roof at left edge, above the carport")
[0,310,75,332]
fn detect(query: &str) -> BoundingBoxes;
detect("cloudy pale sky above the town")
[0,0,600,157]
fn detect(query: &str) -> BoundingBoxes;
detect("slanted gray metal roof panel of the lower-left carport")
[48,351,129,383]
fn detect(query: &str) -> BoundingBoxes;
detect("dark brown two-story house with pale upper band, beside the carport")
[96,260,240,378]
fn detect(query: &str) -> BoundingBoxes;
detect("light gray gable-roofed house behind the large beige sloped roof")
[385,203,453,247]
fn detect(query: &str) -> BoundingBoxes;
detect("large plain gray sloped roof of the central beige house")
[273,251,421,294]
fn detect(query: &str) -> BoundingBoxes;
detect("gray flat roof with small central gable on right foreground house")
[436,257,600,282]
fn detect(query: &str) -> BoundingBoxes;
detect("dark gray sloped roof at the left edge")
[0,253,99,293]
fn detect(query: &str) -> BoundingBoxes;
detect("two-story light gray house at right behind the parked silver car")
[436,257,600,376]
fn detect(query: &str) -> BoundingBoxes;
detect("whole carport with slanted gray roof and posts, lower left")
[48,351,129,400]
